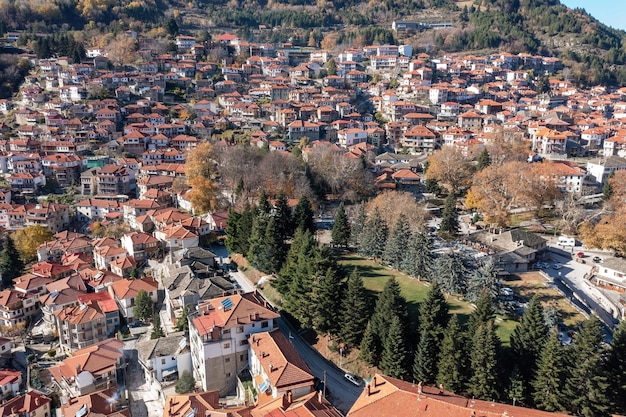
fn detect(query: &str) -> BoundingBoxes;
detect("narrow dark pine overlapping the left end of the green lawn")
[341,269,369,347]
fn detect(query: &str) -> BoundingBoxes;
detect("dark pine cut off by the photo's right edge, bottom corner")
[607,320,626,415]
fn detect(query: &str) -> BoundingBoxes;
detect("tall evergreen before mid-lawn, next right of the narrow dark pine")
[370,278,408,363]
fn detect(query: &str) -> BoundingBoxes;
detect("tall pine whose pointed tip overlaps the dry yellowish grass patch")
[511,295,548,394]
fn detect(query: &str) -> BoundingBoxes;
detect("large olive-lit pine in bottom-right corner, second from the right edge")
[565,316,609,417]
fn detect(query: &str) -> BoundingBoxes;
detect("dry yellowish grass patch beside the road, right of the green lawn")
[504,271,585,327]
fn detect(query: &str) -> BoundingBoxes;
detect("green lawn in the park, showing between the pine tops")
[339,253,517,344]
